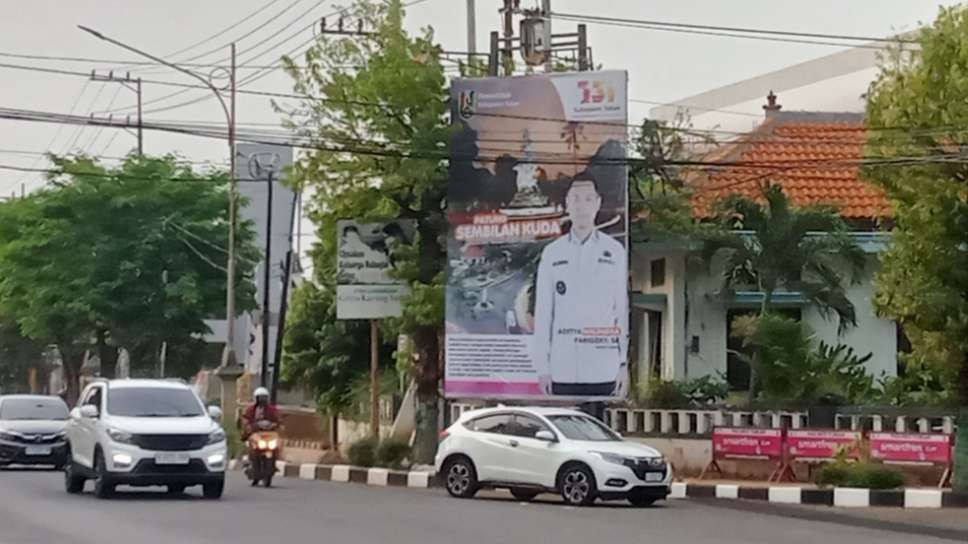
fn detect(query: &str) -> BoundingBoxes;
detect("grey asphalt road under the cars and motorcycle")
[0,470,950,544]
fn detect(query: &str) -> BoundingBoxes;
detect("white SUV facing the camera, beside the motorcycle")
[64,380,228,499]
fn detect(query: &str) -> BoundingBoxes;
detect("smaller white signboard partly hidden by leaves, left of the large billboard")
[336,220,416,319]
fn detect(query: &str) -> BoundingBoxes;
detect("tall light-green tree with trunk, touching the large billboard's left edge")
[280,0,451,462]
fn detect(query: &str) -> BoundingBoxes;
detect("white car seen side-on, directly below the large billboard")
[435,407,672,506]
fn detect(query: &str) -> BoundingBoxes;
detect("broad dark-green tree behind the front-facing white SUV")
[0,155,257,400]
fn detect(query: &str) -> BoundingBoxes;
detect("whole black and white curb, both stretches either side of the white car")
[229,461,968,508]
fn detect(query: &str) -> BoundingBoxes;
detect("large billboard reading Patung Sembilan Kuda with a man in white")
[444,71,628,400]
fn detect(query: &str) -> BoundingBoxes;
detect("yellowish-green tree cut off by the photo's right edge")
[864,6,968,490]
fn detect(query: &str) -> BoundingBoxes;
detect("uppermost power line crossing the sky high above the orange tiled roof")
[551,13,920,46]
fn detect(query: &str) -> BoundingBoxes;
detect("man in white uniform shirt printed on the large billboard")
[533,173,628,397]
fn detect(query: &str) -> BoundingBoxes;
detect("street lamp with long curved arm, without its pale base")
[78,25,237,370]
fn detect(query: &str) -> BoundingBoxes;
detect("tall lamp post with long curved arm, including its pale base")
[78,25,242,421]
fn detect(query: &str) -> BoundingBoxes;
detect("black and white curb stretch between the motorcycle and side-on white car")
[229,460,437,489]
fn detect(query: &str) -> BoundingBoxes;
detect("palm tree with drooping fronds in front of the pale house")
[703,185,866,400]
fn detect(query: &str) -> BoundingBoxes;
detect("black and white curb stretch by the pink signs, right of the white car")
[669,483,968,508]
